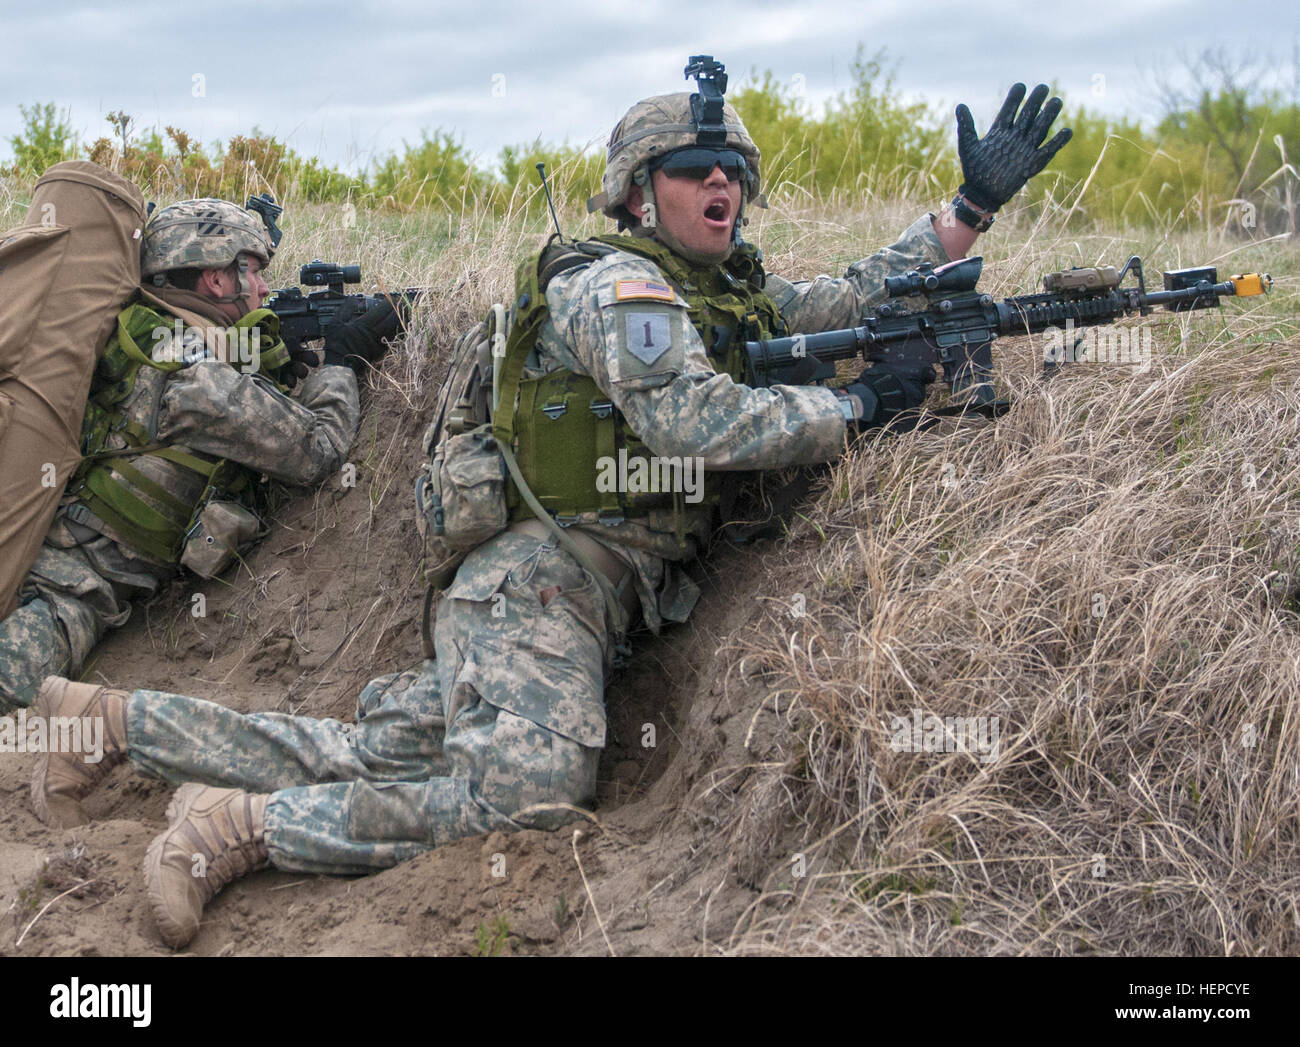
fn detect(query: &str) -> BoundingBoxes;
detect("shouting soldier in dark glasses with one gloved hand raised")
[33,69,1060,947]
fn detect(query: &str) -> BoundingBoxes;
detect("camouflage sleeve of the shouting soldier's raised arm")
[764,215,950,334]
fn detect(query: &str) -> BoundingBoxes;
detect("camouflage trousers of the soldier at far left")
[0,540,131,713]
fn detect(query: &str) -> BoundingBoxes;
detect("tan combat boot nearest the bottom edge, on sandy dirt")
[144,783,268,949]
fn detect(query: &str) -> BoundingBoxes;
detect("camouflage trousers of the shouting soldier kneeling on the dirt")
[126,535,611,873]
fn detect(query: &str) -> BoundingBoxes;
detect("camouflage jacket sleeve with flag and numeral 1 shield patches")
[536,252,845,470]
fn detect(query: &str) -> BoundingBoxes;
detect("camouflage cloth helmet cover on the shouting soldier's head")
[586,91,764,219]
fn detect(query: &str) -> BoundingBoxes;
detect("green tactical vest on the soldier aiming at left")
[66,303,289,563]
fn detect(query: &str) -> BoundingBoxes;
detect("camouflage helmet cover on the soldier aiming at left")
[140,198,276,280]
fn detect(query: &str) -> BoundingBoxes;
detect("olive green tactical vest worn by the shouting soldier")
[493,235,787,530]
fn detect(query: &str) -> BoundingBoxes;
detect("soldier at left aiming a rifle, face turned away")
[0,200,377,713]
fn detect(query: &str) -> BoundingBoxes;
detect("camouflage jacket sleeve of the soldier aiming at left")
[157,360,361,485]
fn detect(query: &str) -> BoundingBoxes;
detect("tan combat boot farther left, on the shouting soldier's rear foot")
[29,676,127,828]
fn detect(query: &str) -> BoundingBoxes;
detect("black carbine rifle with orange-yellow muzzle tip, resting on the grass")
[745,255,1273,415]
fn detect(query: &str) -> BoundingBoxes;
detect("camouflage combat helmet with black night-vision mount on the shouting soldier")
[586,55,767,253]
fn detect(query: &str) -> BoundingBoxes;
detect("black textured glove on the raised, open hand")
[953,83,1074,232]
